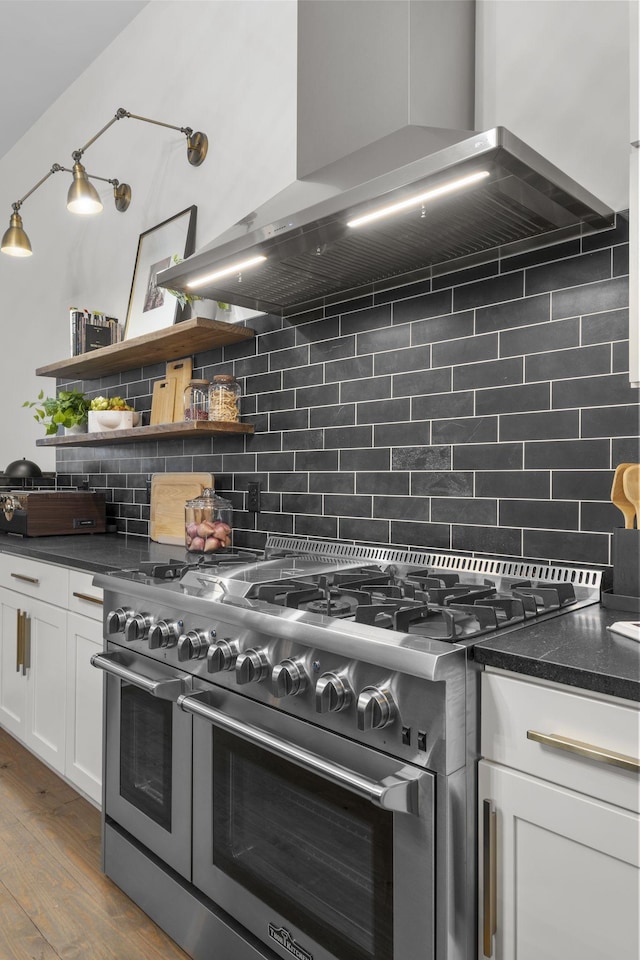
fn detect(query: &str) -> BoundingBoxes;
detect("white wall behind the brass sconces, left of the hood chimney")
[0,0,297,470]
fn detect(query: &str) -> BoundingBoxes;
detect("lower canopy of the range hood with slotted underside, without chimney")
[158,128,614,314]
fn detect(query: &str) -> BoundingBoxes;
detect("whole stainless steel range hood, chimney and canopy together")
[158,0,614,315]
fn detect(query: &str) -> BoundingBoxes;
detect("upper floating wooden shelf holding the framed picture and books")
[36,317,255,376]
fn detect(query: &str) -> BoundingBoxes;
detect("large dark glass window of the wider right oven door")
[213,729,393,960]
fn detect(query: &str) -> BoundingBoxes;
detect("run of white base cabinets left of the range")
[0,554,102,804]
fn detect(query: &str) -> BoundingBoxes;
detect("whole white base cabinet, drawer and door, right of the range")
[478,671,640,960]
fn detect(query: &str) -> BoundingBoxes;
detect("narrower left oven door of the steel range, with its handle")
[91,644,193,879]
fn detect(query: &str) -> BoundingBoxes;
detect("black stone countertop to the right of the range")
[473,603,640,700]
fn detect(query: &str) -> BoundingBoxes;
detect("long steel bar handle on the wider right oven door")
[178,694,425,816]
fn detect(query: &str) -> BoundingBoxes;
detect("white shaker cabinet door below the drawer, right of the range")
[479,761,640,960]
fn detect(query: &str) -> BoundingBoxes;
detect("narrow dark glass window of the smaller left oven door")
[120,683,173,830]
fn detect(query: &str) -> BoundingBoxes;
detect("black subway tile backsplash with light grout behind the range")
[57,215,640,564]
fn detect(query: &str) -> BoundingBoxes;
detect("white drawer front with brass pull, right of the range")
[481,671,640,811]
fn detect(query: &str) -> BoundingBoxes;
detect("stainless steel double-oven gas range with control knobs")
[92,537,601,960]
